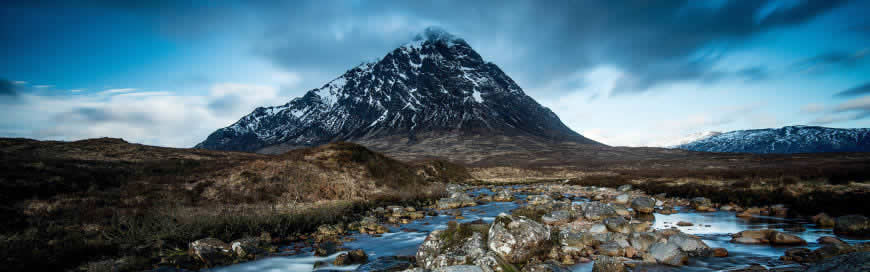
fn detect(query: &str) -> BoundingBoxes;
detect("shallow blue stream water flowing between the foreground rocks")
[212,189,866,272]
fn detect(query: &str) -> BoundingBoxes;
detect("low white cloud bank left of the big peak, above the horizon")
[0,83,290,147]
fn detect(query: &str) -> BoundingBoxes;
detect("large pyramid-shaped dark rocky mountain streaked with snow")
[196,28,601,153]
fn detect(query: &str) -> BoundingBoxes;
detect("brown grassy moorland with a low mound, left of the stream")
[0,139,450,271]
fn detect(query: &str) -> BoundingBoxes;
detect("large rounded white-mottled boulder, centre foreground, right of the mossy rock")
[488,214,550,263]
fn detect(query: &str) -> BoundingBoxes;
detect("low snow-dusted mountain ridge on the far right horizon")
[676,126,870,154]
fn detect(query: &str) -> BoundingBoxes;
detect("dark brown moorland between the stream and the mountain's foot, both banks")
[0,138,870,270]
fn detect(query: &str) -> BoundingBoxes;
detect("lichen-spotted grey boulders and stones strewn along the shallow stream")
[179,184,870,272]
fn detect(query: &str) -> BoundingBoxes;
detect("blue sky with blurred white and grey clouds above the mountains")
[0,0,870,147]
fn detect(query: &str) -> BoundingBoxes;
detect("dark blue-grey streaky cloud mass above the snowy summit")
[16,0,847,94]
